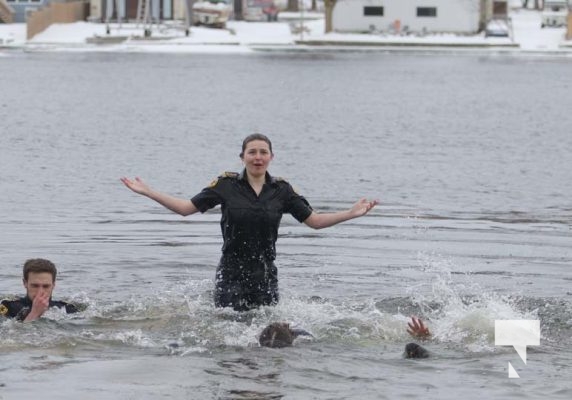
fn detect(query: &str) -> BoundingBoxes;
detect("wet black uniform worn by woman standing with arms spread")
[191,171,312,311]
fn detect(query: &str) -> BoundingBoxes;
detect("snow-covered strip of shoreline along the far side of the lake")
[0,10,572,55]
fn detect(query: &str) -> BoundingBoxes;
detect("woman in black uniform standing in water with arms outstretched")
[121,133,377,311]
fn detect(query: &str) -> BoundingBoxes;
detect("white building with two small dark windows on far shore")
[332,0,488,33]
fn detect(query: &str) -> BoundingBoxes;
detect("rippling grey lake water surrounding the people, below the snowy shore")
[0,52,572,400]
